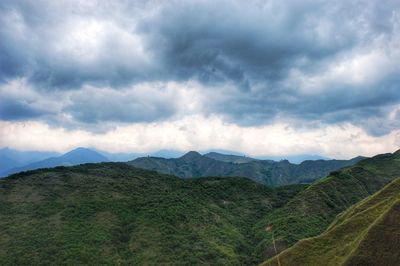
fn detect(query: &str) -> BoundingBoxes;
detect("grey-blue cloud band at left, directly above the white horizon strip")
[0,79,203,131]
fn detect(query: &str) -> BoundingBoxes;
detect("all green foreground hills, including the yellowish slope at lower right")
[0,151,400,266]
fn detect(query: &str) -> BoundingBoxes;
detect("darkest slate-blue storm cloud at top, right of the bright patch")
[139,1,358,85]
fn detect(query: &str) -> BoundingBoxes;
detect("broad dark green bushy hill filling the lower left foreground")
[0,163,304,265]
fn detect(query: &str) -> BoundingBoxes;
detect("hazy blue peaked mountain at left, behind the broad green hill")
[3,148,109,176]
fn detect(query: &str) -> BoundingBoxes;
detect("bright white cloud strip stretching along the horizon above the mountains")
[0,116,400,158]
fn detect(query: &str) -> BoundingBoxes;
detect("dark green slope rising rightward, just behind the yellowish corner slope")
[254,152,400,259]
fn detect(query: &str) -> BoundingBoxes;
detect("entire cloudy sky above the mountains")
[0,0,400,158]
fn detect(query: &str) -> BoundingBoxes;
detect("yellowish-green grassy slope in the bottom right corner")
[263,179,400,266]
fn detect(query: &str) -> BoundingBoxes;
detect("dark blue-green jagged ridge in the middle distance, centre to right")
[128,151,362,186]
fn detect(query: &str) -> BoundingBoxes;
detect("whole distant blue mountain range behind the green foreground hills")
[0,148,362,186]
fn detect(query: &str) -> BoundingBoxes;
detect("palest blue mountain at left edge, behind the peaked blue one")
[0,148,58,176]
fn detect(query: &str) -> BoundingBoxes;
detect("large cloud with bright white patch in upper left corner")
[0,1,153,90]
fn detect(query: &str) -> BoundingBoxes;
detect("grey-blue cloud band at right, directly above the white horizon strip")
[209,73,400,135]
